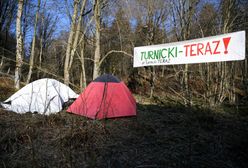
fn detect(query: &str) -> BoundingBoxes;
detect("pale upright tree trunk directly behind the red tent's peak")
[93,0,101,79]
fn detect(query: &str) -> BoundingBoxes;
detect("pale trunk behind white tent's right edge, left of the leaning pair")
[64,0,79,85]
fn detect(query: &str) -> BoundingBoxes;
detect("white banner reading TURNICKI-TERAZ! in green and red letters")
[133,31,245,67]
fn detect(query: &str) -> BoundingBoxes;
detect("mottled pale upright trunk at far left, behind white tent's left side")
[15,0,23,89]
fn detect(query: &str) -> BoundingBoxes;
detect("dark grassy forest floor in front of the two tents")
[0,78,248,168]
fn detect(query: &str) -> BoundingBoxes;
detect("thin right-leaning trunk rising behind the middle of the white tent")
[26,0,40,84]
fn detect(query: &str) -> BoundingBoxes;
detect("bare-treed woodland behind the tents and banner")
[0,0,248,106]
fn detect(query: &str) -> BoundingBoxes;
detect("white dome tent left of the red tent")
[1,78,78,114]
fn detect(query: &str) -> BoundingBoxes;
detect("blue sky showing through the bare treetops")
[16,0,224,49]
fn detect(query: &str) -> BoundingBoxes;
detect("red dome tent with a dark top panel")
[67,74,136,119]
